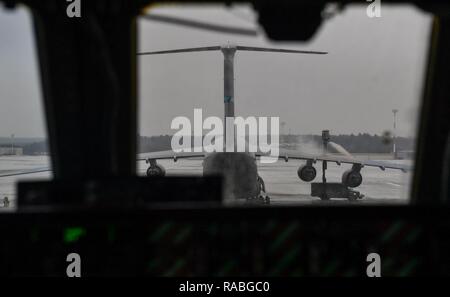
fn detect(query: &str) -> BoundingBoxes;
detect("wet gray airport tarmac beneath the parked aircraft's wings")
[0,156,411,210]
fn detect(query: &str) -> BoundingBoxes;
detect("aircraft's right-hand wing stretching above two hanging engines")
[256,150,412,172]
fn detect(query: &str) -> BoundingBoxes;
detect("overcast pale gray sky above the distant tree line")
[0,5,430,136]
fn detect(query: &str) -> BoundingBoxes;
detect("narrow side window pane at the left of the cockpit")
[0,6,51,211]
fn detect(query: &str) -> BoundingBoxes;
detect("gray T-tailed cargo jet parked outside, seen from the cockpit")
[0,44,410,203]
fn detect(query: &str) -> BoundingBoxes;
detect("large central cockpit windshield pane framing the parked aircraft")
[138,5,431,205]
